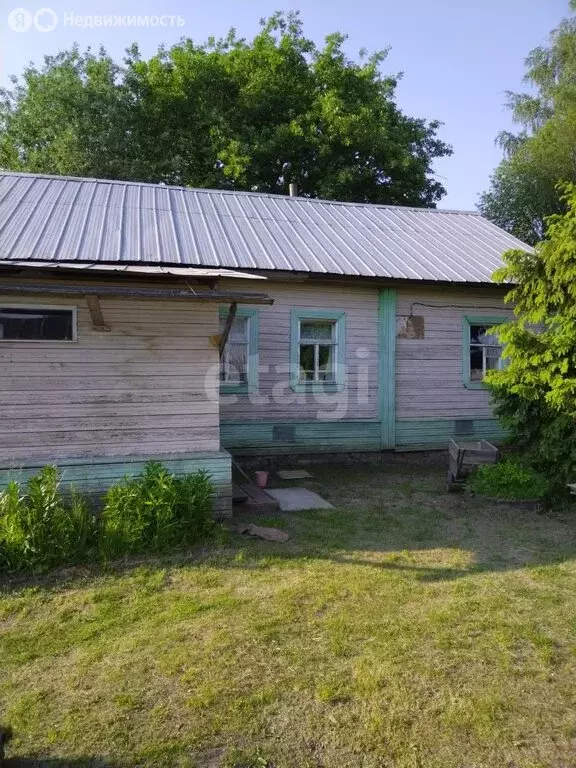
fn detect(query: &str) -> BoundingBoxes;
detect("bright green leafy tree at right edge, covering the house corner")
[488,185,576,492]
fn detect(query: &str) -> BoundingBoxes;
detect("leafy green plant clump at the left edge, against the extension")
[0,466,96,572]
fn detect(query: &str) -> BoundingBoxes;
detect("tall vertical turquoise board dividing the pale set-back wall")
[378,288,396,449]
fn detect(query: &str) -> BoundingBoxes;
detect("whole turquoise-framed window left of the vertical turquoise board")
[290,309,345,391]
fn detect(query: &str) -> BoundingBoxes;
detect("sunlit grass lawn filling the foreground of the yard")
[0,466,576,768]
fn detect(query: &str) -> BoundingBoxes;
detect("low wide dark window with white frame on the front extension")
[0,305,76,341]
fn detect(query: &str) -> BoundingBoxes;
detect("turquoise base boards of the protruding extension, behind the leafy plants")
[0,451,232,515]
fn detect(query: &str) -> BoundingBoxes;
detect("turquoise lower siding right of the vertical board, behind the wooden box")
[396,417,506,450]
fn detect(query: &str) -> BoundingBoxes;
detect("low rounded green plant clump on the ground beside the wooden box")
[468,460,548,501]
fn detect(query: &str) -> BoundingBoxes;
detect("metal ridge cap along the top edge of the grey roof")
[0,169,481,216]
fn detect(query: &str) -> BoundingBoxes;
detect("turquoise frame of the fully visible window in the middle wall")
[290,308,346,392]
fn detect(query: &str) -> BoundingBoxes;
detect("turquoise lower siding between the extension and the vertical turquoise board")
[221,421,380,456]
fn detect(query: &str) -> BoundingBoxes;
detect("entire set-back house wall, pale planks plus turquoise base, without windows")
[222,281,511,454]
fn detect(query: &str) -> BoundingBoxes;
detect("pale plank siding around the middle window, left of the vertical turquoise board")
[221,280,378,424]
